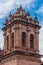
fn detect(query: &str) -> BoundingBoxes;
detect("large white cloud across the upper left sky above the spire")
[0,0,36,19]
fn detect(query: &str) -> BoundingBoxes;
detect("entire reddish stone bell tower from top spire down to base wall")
[2,6,41,65]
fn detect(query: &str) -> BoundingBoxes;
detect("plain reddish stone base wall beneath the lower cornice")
[0,55,41,65]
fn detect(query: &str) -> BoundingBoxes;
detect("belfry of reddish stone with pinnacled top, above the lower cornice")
[3,6,40,53]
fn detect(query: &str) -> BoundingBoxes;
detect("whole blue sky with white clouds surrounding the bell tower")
[0,0,43,54]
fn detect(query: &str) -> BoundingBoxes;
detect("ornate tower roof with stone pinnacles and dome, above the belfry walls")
[4,6,40,28]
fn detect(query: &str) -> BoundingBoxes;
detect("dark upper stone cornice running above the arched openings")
[2,20,41,31]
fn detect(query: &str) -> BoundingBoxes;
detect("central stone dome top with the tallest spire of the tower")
[14,6,26,20]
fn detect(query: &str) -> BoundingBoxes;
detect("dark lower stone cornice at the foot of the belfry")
[0,51,42,60]
